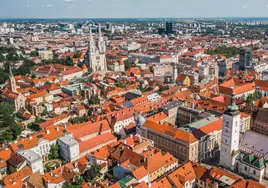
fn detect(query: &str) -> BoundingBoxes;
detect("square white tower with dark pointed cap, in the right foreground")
[220,93,240,169]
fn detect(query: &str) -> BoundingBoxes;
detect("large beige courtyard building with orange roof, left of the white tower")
[141,102,222,161]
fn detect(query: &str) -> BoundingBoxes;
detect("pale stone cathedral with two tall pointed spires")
[87,25,107,72]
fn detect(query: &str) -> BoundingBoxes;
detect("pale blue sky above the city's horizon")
[0,0,268,18]
